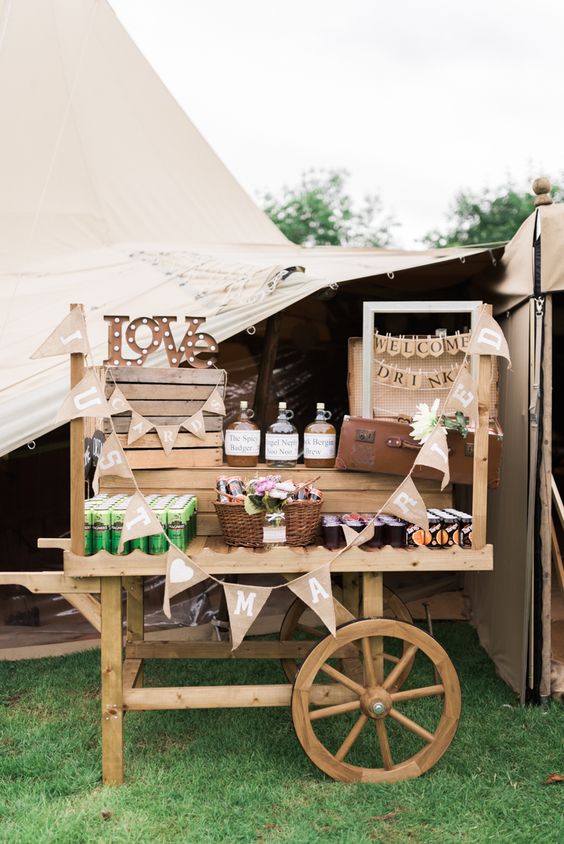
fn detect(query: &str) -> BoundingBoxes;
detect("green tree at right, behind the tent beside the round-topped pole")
[423,183,561,247]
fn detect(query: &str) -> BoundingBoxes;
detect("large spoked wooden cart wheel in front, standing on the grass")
[292,619,461,783]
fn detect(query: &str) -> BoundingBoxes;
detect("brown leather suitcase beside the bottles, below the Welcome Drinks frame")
[335,416,503,488]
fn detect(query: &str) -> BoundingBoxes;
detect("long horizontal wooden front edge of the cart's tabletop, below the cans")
[54,536,493,577]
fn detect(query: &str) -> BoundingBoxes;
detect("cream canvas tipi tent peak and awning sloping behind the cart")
[0,0,491,455]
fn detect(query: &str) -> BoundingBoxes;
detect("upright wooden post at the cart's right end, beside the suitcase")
[472,305,492,549]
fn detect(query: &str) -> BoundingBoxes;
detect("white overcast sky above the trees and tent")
[110,0,564,247]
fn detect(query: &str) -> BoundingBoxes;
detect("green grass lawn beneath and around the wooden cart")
[0,623,564,844]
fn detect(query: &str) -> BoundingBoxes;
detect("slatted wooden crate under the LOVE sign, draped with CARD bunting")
[104,366,225,469]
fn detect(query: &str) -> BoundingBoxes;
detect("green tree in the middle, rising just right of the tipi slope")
[261,169,398,246]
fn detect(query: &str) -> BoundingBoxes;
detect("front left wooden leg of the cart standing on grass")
[100,577,123,785]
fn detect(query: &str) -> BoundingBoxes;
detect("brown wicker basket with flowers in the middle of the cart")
[214,501,322,548]
